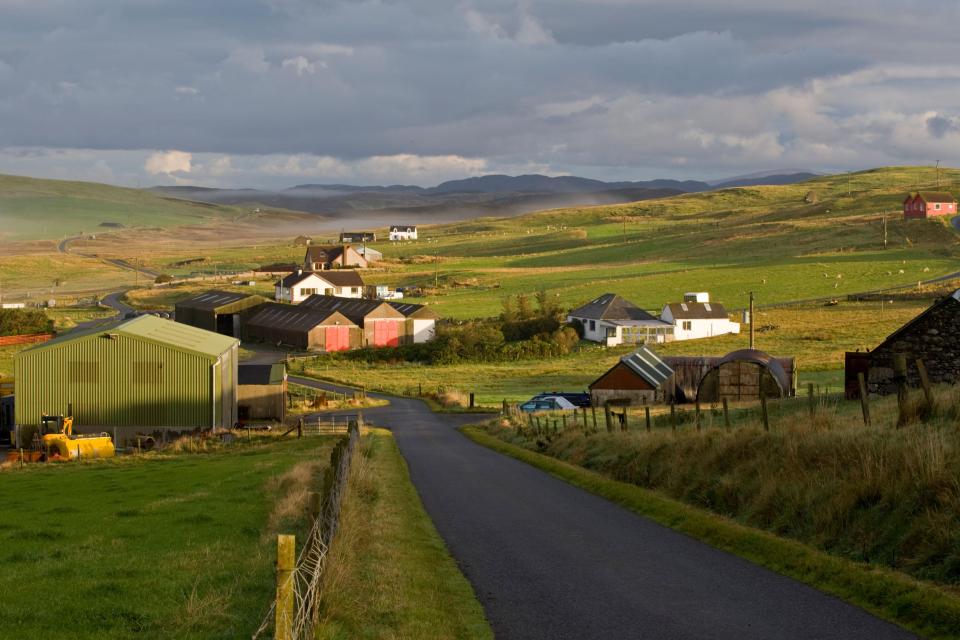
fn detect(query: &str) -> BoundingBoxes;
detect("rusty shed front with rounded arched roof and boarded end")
[696,349,794,403]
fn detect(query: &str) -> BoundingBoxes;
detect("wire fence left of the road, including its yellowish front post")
[252,422,360,640]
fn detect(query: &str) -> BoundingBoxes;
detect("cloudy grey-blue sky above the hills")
[0,0,960,188]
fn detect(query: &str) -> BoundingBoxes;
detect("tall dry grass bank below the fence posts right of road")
[488,388,960,586]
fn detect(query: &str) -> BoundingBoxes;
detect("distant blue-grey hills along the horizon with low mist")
[151,173,813,218]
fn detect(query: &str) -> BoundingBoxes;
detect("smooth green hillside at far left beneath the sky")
[0,175,240,241]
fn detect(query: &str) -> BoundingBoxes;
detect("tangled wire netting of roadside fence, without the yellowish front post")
[251,427,360,640]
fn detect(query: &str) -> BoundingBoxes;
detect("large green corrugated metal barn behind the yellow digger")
[14,315,239,443]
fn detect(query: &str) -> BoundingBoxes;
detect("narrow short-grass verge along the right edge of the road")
[462,427,960,638]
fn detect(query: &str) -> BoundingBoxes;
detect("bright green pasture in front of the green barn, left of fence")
[0,439,331,640]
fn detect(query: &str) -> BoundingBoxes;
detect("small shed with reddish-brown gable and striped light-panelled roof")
[589,346,673,407]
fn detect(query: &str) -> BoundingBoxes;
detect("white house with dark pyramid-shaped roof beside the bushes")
[567,293,673,347]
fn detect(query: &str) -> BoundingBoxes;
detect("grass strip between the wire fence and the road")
[317,429,493,640]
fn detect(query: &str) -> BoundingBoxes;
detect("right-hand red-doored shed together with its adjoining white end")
[300,295,436,347]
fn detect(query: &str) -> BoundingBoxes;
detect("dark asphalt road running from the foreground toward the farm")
[291,376,914,640]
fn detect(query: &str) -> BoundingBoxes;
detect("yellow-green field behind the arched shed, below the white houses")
[305,301,928,406]
